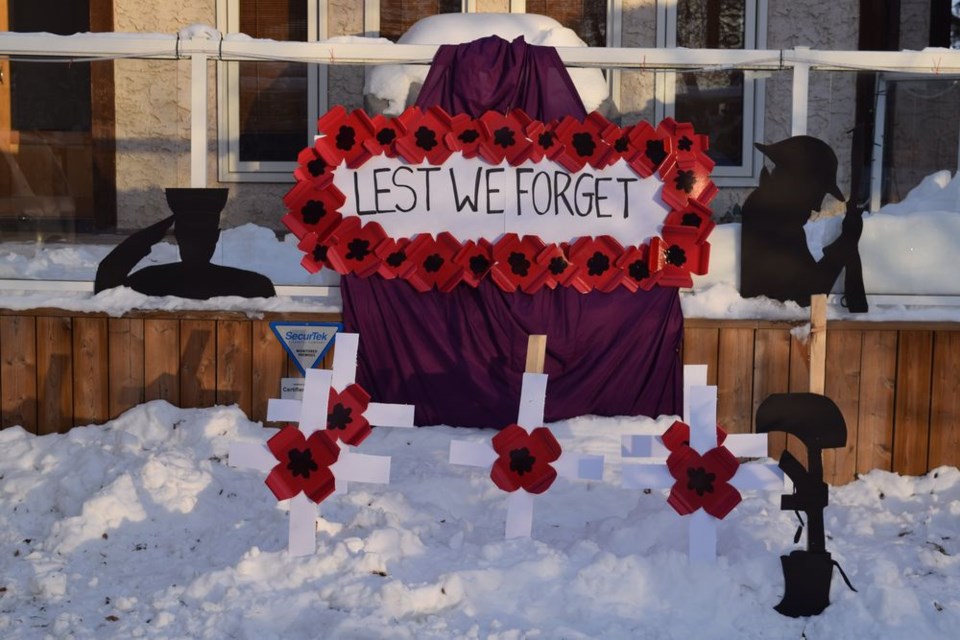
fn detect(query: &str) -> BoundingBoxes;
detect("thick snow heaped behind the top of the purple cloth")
[363,13,609,115]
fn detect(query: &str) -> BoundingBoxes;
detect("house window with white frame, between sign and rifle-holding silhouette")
[657,0,765,186]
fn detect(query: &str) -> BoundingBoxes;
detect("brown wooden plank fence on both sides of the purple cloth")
[0,310,960,484]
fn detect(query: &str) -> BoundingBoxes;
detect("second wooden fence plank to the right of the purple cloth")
[717,328,754,433]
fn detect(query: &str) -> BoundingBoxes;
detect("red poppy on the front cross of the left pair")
[266,426,340,503]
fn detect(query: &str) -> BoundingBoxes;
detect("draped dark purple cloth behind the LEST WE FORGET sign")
[341,36,683,428]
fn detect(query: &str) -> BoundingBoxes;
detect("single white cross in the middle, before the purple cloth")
[450,373,603,539]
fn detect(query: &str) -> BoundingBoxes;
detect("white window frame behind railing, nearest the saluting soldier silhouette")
[217,0,327,182]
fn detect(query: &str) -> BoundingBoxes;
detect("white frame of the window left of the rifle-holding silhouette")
[654,0,767,187]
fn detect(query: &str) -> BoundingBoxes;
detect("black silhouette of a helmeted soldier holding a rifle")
[740,136,867,312]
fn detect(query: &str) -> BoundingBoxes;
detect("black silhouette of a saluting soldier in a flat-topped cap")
[94,189,276,300]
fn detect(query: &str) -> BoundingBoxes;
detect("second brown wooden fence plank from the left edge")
[37,316,73,435]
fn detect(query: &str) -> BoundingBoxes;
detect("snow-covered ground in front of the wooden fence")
[0,401,960,640]
